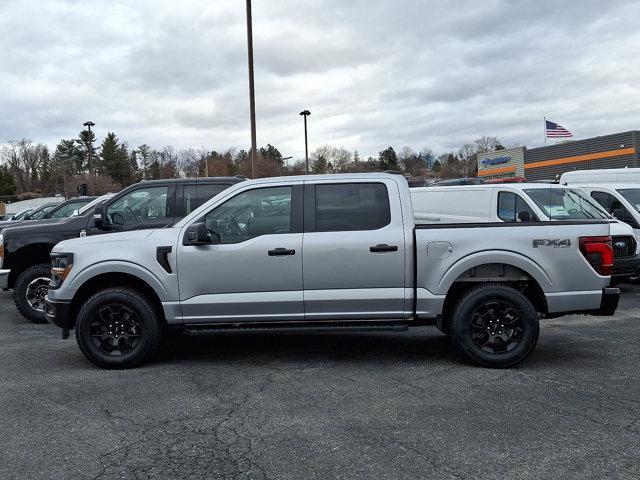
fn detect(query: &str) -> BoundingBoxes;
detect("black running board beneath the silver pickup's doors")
[182,323,409,336]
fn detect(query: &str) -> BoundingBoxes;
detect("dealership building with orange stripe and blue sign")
[478,130,640,181]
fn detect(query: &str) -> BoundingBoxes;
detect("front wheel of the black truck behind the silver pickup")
[13,263,51,323]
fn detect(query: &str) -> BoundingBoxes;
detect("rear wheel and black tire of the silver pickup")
[450,283,540,368]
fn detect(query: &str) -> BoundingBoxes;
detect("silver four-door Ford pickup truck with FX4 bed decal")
[45,173,619,368]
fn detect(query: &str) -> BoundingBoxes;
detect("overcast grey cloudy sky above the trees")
[0,0,640,158]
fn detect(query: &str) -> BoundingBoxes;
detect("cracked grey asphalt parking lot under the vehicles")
[0,287,640,479]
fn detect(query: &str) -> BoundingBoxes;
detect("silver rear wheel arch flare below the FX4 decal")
[438,250,553,294]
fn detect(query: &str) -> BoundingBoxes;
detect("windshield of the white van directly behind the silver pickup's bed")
[524,188,610,220]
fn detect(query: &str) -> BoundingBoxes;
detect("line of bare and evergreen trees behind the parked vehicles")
[0,130,504,197]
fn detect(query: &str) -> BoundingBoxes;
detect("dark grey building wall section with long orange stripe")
[524,130,640,180]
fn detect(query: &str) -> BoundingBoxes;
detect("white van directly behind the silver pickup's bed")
[411,183,640,283]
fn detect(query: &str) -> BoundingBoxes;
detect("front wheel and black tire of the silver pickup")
[76,287,164,369]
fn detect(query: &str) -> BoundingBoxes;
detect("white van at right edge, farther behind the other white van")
[560,168,640,243]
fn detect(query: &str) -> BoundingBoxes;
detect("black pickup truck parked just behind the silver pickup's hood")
[0,177,242,323]
